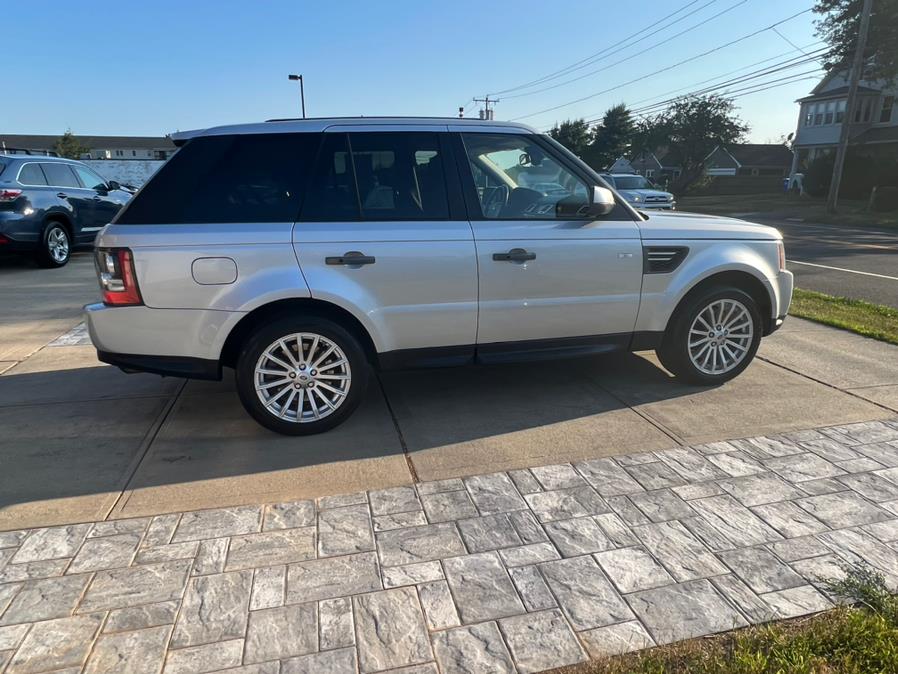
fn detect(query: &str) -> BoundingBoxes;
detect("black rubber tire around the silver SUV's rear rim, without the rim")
[236,317,370,435]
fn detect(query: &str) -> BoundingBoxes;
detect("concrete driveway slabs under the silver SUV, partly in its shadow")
[0,255,898,530]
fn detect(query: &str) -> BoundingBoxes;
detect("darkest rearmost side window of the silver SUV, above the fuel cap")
[116,133,320,225]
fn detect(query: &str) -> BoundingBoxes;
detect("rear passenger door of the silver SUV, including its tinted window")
[293,125,477,365]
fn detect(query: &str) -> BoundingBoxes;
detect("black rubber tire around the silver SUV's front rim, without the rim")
[658,288,763,386]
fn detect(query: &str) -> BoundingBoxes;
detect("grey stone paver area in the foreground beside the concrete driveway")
[0,420,898,674]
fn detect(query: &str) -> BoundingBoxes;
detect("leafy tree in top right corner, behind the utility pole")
[814,0,898,82]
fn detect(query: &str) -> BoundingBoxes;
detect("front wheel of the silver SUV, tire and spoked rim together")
[656,287,763,386]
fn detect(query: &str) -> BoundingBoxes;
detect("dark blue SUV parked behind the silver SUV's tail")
[0,154,131,267]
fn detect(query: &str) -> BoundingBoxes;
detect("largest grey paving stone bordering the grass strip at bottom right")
[627,579,747,644]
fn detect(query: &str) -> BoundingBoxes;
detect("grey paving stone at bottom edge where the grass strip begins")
[499,609,586,674]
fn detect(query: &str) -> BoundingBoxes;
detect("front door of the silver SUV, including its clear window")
[461,129,642,356]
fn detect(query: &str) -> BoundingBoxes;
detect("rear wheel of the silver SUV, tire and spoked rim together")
[237,317,369,435]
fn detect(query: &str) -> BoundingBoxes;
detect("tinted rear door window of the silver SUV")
[303,132,449,221]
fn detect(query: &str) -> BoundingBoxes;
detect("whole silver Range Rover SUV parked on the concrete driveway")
[85,118,792,435]
